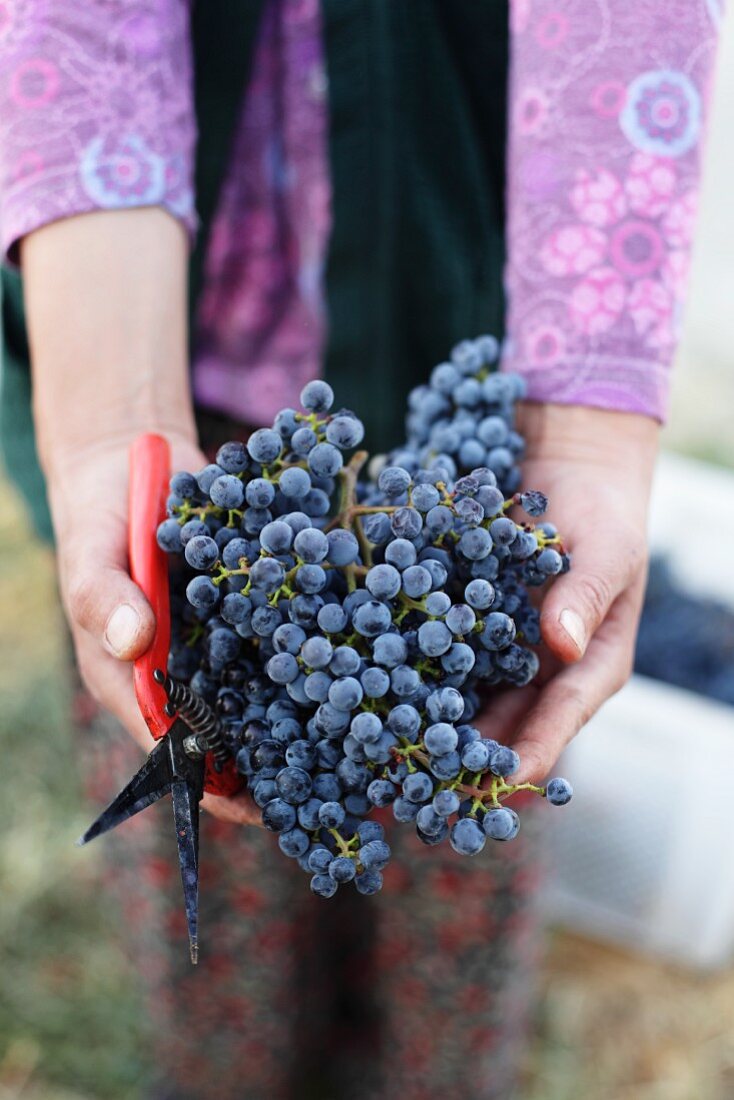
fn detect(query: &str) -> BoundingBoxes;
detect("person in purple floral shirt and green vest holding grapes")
[0,0,721,1100]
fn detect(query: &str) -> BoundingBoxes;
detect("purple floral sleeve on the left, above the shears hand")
[0,0,195,256]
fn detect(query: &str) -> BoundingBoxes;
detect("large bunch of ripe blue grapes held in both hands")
[158,337,572,897]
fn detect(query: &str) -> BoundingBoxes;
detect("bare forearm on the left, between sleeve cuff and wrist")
[21,208,195,480]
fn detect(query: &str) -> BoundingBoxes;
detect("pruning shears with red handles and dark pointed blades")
[77,435,242,963]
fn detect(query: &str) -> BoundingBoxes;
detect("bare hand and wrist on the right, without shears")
[482,404,658,782]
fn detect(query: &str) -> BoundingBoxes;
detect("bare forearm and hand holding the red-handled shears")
[22,208,259,824]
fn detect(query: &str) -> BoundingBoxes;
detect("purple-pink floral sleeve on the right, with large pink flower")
[505,0,723,419]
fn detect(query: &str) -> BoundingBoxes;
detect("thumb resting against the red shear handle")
[59,515,155,661]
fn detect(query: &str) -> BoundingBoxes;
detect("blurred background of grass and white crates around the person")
[0,20,734,1100]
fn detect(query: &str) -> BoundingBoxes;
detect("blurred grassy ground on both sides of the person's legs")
[0,484,734,1100]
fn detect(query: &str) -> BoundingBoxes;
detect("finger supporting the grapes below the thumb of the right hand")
[513,579,644,783]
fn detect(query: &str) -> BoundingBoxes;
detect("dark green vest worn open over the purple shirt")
[0,0,507,537]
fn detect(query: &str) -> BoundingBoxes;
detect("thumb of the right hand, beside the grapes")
[540,528,645,663]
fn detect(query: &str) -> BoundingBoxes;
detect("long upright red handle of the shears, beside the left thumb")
[129,436,174,739]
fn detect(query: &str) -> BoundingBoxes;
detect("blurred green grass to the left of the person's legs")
[0,488,149,1100]
